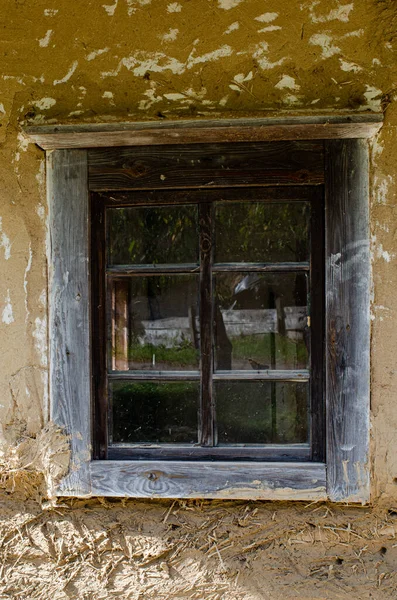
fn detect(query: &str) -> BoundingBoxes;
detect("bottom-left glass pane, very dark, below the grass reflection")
[110,381,200,444]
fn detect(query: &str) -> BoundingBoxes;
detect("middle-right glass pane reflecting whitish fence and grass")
[214,272,310,370]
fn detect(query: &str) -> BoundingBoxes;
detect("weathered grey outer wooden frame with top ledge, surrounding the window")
[33,115,374,503]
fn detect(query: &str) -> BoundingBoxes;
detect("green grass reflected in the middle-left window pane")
[130,342,198,367]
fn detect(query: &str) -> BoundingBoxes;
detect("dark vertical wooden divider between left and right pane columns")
[199,202,215,446]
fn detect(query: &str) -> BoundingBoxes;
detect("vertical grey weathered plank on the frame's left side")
[47,150,91,495]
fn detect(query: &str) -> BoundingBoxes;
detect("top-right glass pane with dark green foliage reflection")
[215,202,310,262]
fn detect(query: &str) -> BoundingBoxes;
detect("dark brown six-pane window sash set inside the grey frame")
[91,189,324,460]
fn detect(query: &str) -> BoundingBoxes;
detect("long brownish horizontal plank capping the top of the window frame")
[24,113,382,150]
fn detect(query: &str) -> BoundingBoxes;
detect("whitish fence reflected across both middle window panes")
[139,306,307,348]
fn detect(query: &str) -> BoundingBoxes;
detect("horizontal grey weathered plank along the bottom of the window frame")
[91,460,326,501]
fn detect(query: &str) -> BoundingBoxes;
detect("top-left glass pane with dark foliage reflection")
[106,206,199,265]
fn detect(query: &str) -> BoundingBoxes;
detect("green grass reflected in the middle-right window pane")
[232,333,307,365]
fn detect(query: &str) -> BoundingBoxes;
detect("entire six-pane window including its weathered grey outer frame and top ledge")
[28,115,380,502]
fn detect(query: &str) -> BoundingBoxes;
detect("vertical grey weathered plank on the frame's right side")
[326,140,371,503]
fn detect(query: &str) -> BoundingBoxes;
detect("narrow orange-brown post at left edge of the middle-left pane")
[112,280,129,371]
